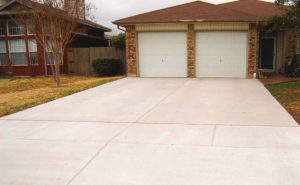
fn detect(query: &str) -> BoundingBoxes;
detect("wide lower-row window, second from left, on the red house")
[9,39,27,66]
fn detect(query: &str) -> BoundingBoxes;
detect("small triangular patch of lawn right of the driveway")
[266,81,300,124]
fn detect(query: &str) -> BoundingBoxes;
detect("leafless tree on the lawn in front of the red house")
[14,0,83,87]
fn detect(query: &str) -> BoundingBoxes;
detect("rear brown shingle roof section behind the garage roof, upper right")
[219,0,285,18]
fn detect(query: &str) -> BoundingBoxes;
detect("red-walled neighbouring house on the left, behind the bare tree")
[0,0,111,76]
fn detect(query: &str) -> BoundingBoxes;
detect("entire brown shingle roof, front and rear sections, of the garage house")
[113,0,286,25]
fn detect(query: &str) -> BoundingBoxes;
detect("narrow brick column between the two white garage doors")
[187,24,196,78]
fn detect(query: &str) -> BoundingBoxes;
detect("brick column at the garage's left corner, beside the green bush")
[125,26,137,77]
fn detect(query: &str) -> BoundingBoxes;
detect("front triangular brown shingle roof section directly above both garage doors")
[114,1,256,24]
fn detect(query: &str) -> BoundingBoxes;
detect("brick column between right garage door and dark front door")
[248,24,259,78]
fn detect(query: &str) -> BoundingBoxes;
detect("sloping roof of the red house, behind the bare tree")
[0,0,111,32]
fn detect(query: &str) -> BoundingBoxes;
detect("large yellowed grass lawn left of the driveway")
[0,76,122,117]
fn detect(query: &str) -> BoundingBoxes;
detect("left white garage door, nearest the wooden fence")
[138,32,187,77]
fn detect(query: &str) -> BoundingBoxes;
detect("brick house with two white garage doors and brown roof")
[114,0,300,78]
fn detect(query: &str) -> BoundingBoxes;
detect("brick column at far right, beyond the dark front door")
[284,32,297,65]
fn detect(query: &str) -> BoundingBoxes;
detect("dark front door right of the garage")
[260,38,275,71]
